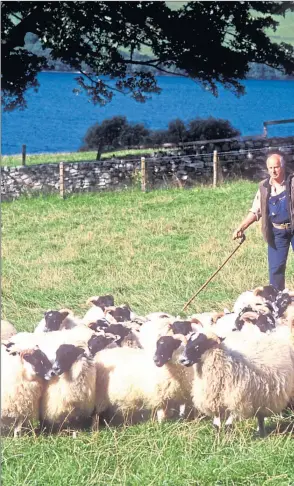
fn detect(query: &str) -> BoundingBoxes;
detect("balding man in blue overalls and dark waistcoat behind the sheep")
[233,154,294,290]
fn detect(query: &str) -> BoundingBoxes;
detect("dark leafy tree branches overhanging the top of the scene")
[1,1,294,110]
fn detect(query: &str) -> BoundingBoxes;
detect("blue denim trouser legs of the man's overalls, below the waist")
[268,228,294,290]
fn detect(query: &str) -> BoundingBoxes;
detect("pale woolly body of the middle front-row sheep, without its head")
[94,340,193,422]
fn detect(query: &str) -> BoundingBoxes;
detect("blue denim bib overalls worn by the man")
[268,191,294,290]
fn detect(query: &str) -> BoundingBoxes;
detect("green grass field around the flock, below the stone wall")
[2,182,294,486]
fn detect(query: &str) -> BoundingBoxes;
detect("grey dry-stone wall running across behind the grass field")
[1,137,294,201]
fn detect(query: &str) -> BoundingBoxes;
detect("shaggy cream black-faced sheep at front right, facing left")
[180,333,294,436]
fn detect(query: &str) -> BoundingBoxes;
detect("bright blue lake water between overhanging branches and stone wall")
[2,73,294,154]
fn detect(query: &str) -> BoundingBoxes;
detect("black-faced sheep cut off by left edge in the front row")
[1,346,52,436]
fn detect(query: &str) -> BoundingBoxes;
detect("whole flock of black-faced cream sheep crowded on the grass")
[1,286,294,436]
